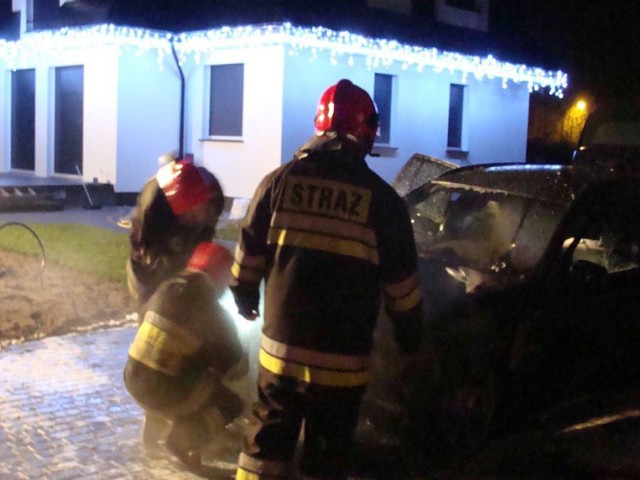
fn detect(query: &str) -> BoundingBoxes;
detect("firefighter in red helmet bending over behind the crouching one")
[126,158,224,304]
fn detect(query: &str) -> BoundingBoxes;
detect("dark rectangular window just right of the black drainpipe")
[209,64,244,137]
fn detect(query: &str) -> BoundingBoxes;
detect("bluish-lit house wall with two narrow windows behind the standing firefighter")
[282,47,529,186]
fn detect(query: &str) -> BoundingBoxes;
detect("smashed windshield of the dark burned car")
[410,183,567,286]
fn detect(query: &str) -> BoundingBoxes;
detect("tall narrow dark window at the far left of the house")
[11,69,36,170]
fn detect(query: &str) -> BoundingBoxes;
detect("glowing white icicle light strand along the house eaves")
[0,23,568,97]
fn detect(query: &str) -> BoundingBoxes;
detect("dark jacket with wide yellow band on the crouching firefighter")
[124,270,245,410]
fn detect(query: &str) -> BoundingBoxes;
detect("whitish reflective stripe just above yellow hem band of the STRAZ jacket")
[260,335,371,372]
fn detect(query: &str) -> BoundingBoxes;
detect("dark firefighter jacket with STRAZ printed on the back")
[231,133,422,387]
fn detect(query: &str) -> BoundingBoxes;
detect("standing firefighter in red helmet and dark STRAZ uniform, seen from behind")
[231,80,422,480]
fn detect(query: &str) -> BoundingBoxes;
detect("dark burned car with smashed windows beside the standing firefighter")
[362,164,640,464]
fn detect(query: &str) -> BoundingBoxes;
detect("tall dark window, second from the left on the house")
[54,66,84,175]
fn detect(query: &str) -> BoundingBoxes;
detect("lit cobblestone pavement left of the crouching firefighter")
[0,327,235,480]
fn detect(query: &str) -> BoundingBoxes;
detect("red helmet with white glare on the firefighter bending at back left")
[156,161,212,215]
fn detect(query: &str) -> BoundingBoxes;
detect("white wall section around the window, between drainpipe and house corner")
[185,46,284,198]
